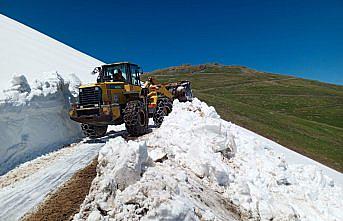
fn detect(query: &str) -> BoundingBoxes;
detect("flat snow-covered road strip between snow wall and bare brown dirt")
[0,141,104,221]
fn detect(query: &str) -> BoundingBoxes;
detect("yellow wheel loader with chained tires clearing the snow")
[69,62,192,138]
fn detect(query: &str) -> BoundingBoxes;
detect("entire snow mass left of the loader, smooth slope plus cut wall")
[0,14,102,175]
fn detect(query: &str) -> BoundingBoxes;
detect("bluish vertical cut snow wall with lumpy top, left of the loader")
[0,73,81,174]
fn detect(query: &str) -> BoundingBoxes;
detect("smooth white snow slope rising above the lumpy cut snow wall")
[0,14,102,98]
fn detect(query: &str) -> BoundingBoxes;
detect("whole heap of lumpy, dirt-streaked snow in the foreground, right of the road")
[74,99,343,220]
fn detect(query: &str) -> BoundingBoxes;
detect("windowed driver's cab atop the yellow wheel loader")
[97,62,142,86]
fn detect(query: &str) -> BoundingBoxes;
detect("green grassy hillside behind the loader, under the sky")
[144,64,343,172]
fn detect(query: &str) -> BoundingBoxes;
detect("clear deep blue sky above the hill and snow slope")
[0,0,343,84]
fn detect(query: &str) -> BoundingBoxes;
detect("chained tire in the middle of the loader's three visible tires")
[124,101,149,136]
